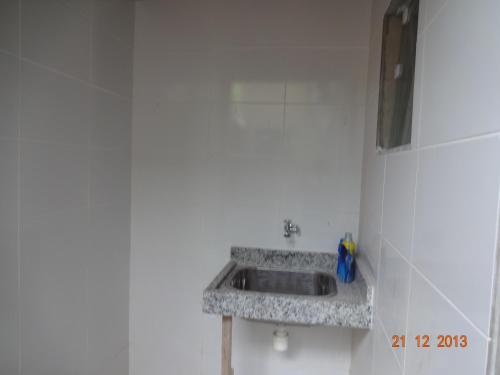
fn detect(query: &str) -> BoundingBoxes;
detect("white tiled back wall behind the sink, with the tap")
[131,0,370,375]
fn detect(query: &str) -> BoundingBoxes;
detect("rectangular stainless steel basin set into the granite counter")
[229,268,337,296]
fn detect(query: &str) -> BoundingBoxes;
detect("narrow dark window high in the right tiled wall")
[377,0,419,150]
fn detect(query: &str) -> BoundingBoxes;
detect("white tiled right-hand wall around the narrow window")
[352,0,500,375]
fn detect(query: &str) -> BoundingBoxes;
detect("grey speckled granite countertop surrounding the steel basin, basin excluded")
[203,247,374,329]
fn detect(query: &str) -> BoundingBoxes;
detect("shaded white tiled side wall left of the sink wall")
[0,0,133,375]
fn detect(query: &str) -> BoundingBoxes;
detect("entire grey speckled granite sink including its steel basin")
[202,246,374,329]
